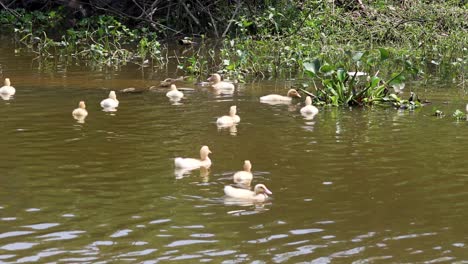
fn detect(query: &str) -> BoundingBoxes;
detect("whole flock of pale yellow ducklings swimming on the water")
[0,73,319,202]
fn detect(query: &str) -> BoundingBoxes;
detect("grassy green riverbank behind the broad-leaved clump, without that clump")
[0,1,468,83]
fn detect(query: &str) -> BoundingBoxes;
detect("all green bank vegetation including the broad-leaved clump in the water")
[0,0,468,101]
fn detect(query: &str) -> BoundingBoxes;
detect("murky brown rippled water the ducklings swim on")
[0,45,468,263]
